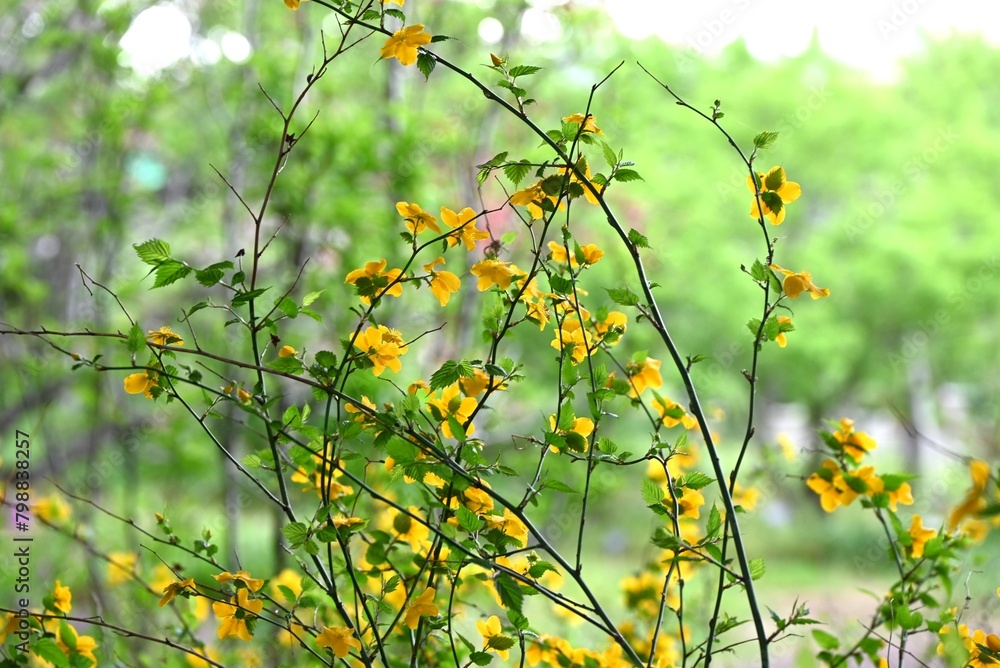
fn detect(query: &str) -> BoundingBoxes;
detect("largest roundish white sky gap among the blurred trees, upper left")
[120,5,192,76]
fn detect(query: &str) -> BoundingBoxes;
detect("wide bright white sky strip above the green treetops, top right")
[604,0,1000,80]
